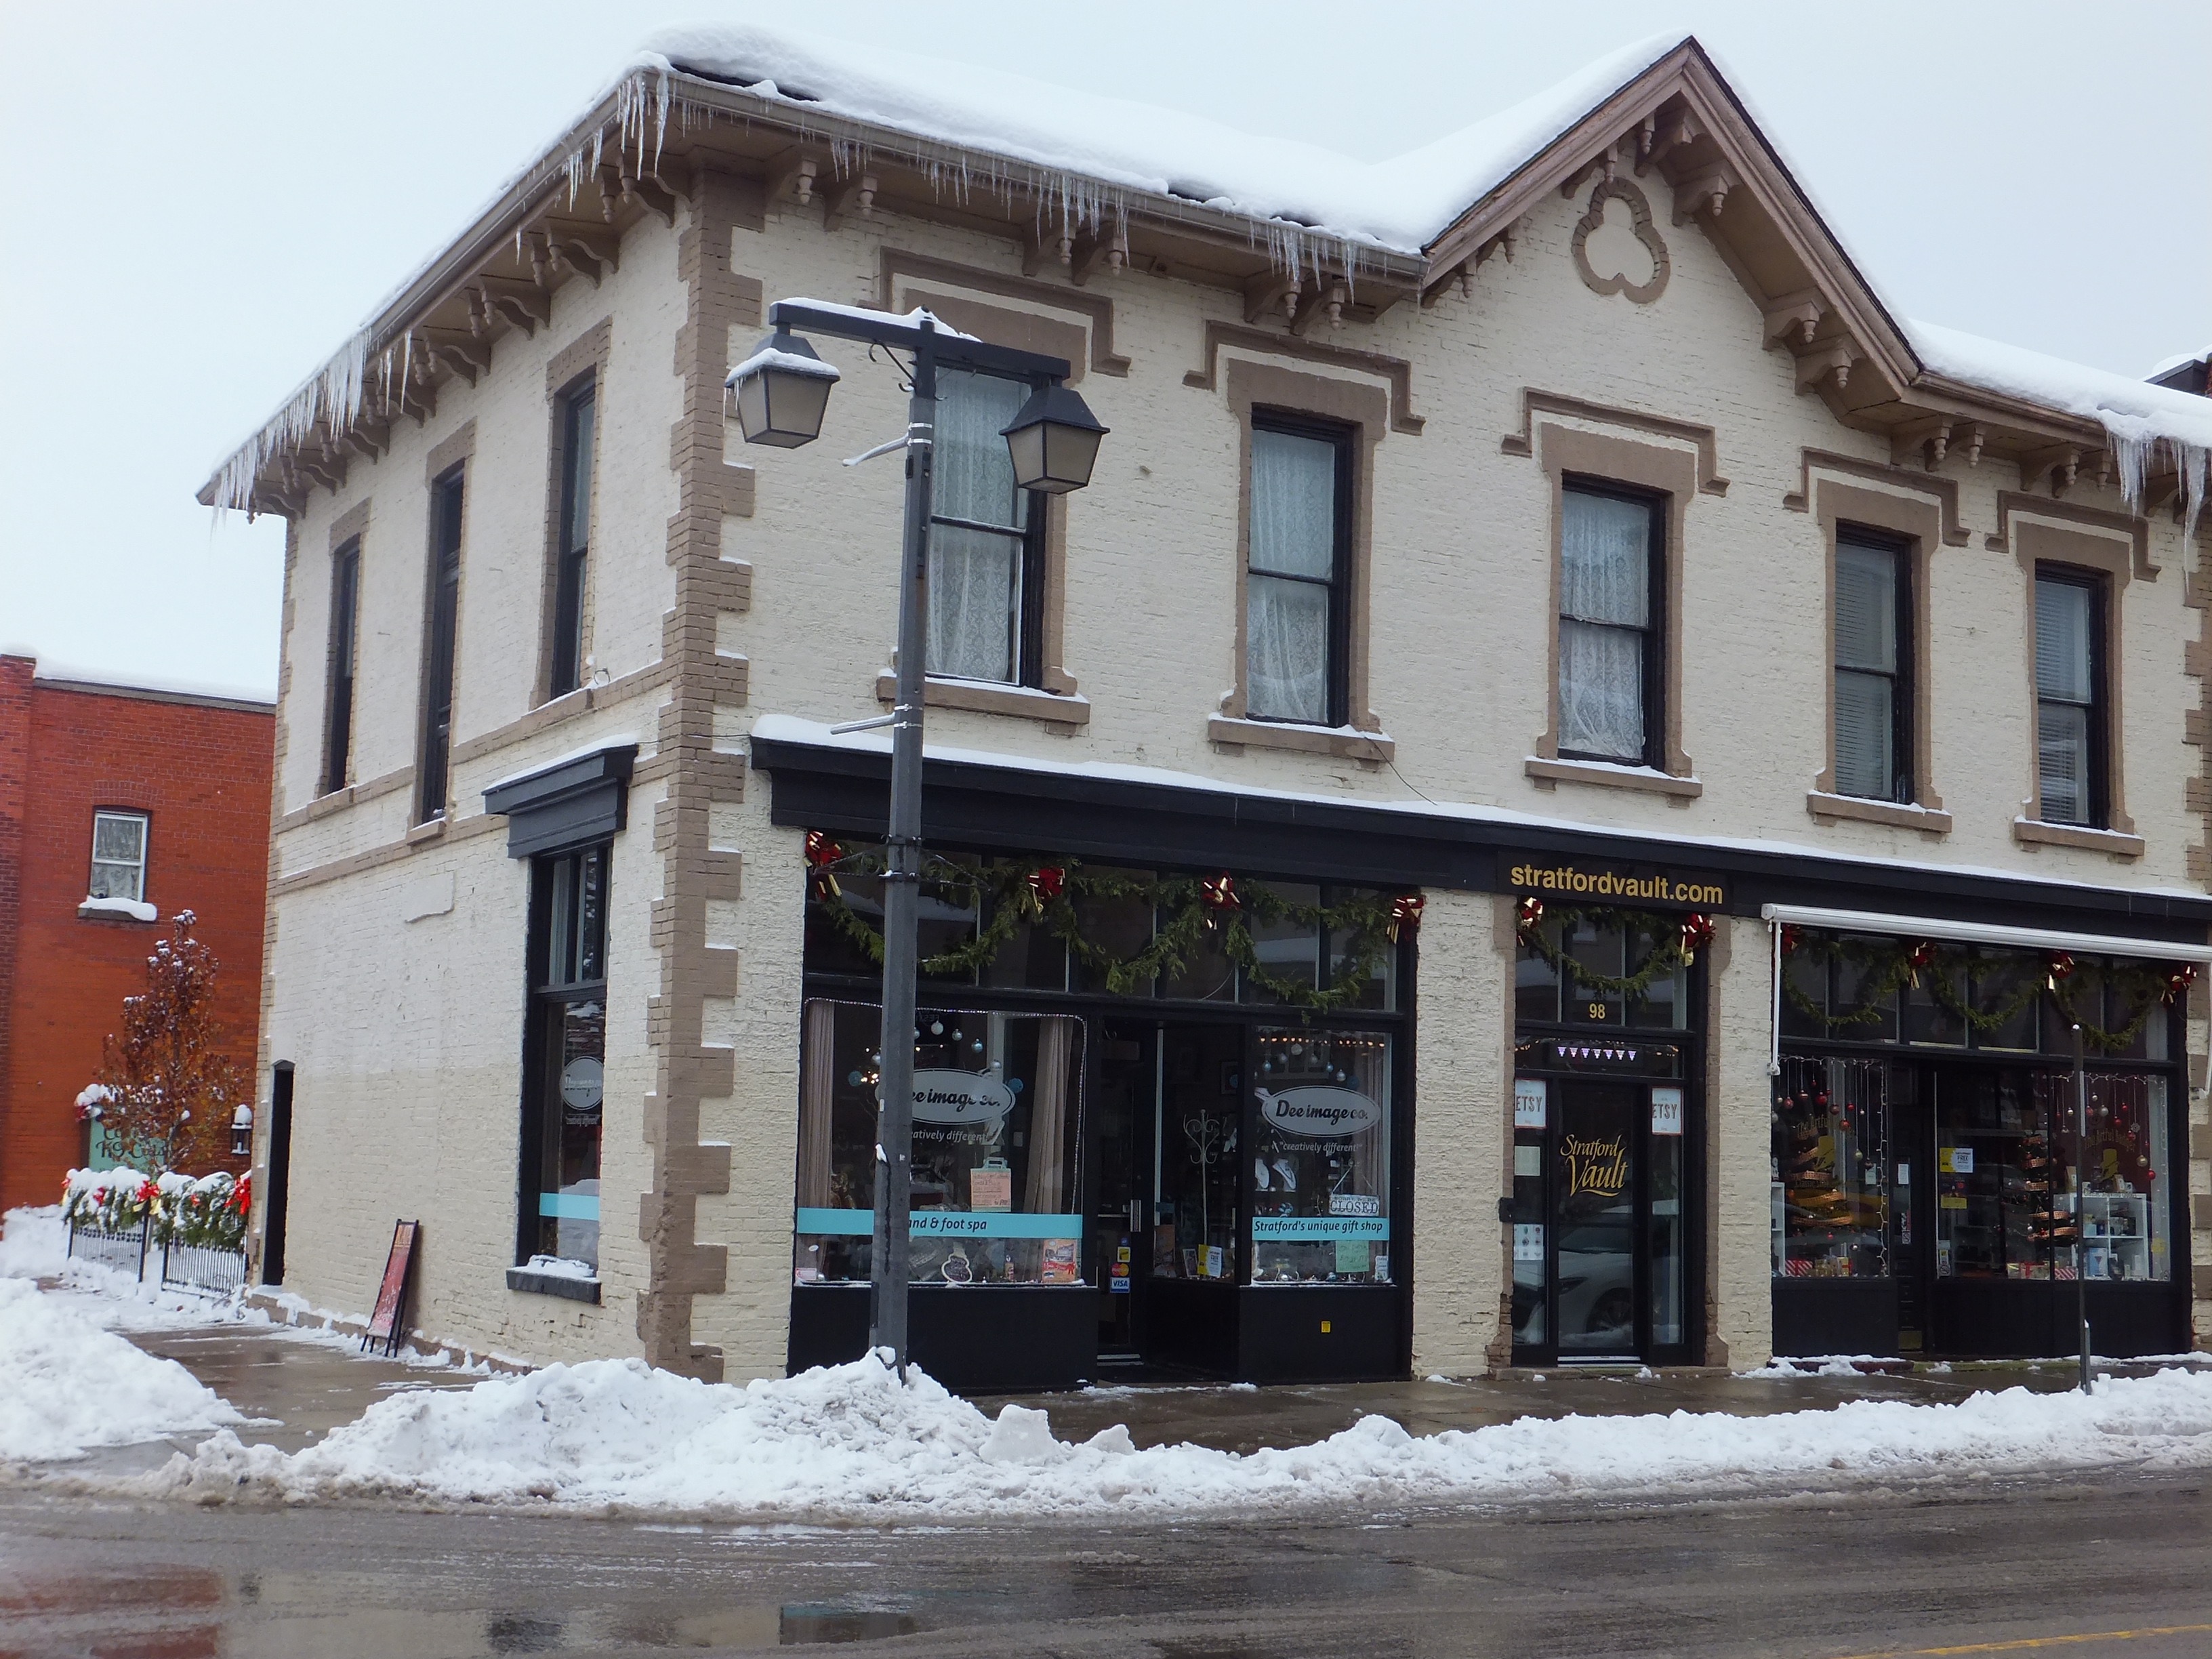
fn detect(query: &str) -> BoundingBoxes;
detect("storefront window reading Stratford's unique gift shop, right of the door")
[1252,1026,1391,1285]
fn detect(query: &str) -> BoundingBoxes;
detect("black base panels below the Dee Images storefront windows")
[790,1279,1407,1393]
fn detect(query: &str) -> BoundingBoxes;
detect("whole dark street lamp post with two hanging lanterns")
[728,299,1106,1376]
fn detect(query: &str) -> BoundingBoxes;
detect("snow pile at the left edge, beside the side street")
[0,1283,243,1462]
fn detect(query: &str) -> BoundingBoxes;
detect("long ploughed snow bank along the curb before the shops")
[148,1358,2212,1519]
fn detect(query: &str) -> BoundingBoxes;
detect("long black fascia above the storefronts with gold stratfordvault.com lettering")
[752,737,2212,945]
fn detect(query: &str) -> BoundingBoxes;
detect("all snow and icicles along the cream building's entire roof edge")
[203,22,2212,522]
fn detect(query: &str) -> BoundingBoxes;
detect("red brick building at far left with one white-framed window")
[0,655,274,1210]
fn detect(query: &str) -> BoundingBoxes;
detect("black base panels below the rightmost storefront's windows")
[1774,1279,2190,1360]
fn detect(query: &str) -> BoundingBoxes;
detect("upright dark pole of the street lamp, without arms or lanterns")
[867,319,938,1376]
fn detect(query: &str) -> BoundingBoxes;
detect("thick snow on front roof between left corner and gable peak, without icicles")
[639,22,1685,254]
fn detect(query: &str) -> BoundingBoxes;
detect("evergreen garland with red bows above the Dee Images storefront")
[807,858,1420,1013]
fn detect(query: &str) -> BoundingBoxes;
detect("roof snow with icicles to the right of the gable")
[1904,321,2212,533]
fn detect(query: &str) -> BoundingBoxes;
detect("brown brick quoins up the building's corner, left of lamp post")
[637,166,765,1380]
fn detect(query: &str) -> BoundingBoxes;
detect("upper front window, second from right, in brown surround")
[1836,529,1913,801]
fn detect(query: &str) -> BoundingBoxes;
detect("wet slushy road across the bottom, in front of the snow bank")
[0,1473,2212,1659]
